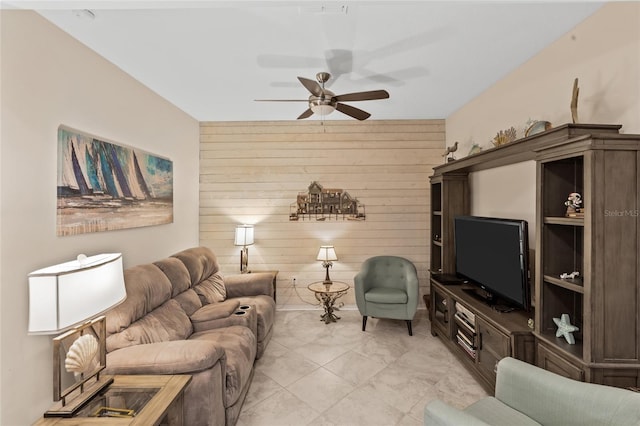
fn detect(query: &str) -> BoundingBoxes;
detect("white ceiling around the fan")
[18,0,602,121]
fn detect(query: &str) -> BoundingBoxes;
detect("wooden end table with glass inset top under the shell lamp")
[34,375,191,426]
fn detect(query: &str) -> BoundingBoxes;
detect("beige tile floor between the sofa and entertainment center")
[237,309,486,426]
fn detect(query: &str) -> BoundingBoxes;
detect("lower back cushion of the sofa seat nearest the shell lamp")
[107,299,193,352]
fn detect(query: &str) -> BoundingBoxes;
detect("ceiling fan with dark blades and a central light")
[256,72,389,120]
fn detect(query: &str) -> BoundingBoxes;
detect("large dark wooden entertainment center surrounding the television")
[430,124,640,392]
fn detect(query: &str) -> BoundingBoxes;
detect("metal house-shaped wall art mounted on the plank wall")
[289,181,366,220]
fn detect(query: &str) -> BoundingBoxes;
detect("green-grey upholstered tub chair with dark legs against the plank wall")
[354,256,419,336]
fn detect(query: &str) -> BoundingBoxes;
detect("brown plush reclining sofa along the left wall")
[106,247,275,426]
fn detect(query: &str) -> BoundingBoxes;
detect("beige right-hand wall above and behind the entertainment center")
[446,2,640,246]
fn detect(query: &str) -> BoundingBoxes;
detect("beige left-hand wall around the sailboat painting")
[0,11,199,426]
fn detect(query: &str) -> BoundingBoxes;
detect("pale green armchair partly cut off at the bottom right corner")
[424,357,640,426]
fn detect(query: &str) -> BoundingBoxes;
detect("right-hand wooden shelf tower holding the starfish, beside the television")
[535,133,640,387]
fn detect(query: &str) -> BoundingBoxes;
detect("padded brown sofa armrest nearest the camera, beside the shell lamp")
[105,340,225,374]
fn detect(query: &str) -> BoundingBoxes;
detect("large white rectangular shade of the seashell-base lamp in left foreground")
[29,253,127,334]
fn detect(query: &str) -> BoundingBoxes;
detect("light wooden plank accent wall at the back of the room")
[200,119,445,309]
